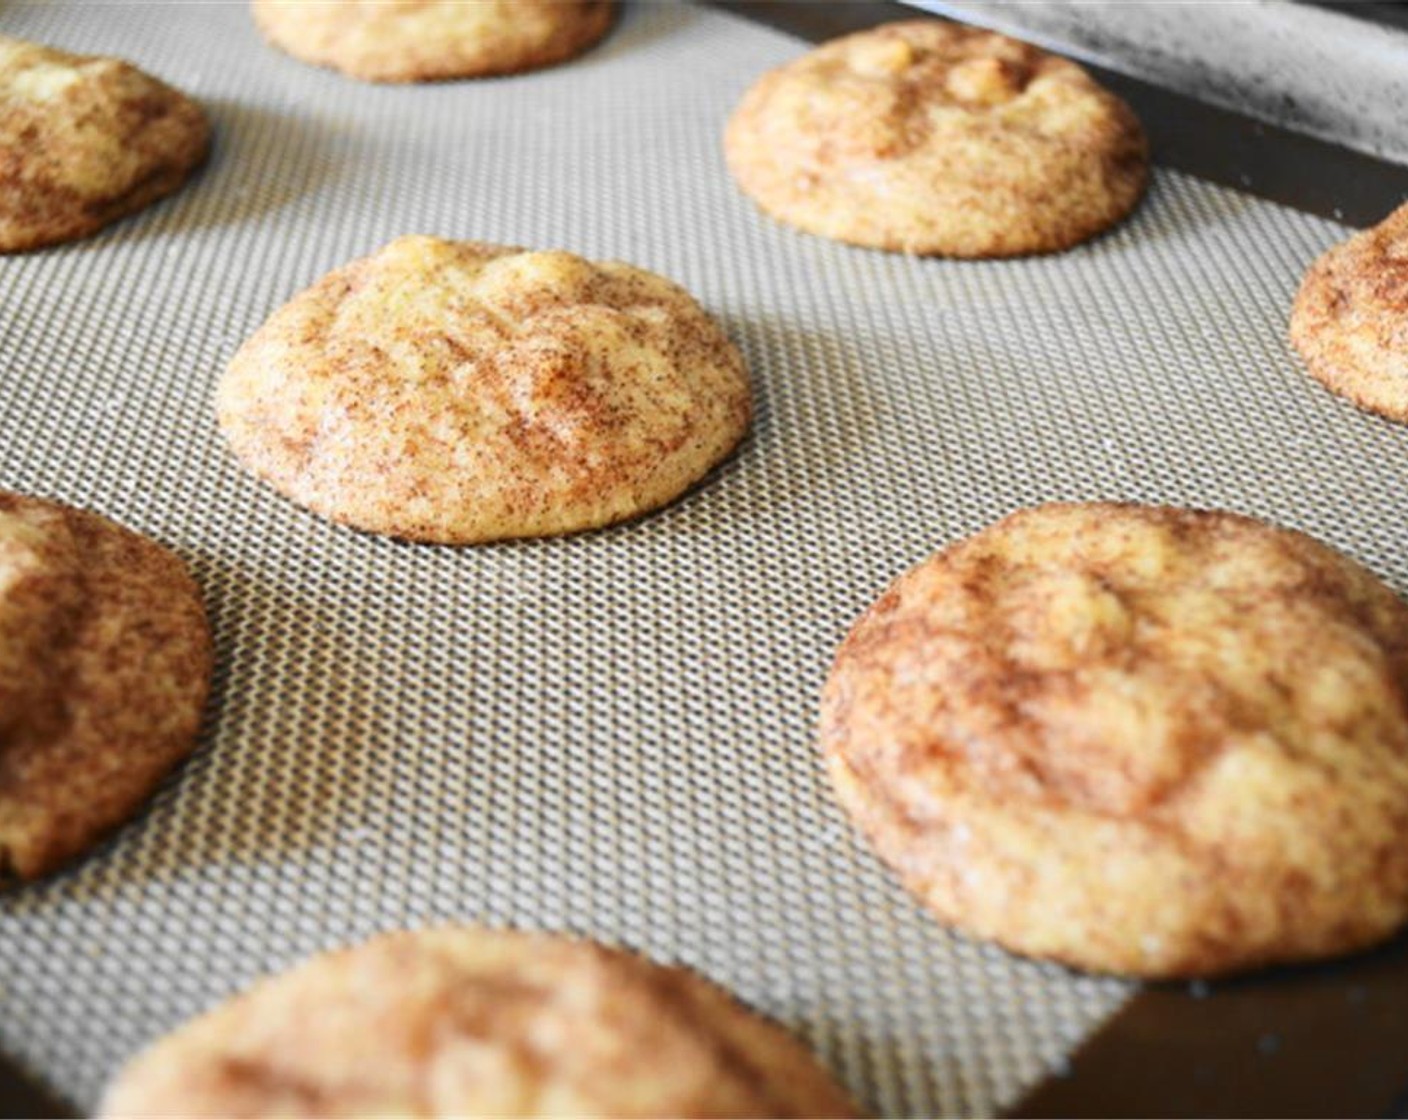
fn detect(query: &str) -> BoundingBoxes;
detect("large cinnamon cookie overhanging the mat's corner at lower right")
[821,504,1408,976]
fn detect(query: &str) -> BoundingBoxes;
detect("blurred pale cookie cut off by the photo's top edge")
[253,0,615,82]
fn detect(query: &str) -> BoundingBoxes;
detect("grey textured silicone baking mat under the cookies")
[0,3,1408,1113]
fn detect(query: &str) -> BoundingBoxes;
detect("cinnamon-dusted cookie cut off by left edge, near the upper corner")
[0,35,210,252]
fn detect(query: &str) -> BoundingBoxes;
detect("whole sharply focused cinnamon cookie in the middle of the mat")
[217,237,750,544]
